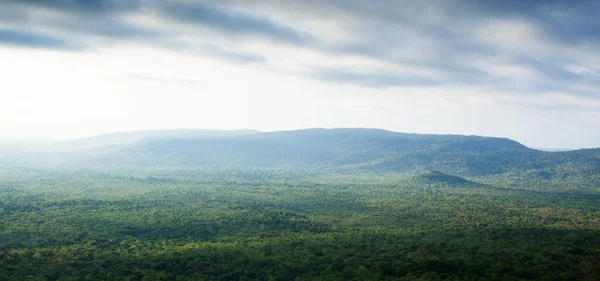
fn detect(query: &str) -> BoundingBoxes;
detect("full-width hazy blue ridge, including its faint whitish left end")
[0,128,600,183]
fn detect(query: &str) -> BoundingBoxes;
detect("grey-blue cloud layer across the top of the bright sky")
[0,0,600,93]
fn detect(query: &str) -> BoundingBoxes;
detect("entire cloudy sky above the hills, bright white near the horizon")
[0,0,600,148]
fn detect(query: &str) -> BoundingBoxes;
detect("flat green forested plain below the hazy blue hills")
[0,168,600,281]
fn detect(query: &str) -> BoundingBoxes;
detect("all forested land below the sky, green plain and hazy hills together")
[0,129,600,281]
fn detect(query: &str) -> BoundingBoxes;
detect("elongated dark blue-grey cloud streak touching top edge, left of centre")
[158,2,312,44]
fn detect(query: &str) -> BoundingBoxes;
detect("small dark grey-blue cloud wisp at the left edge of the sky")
[0,28,76,49]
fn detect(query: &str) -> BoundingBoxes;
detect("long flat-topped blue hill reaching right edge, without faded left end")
[88,129,600,179]
